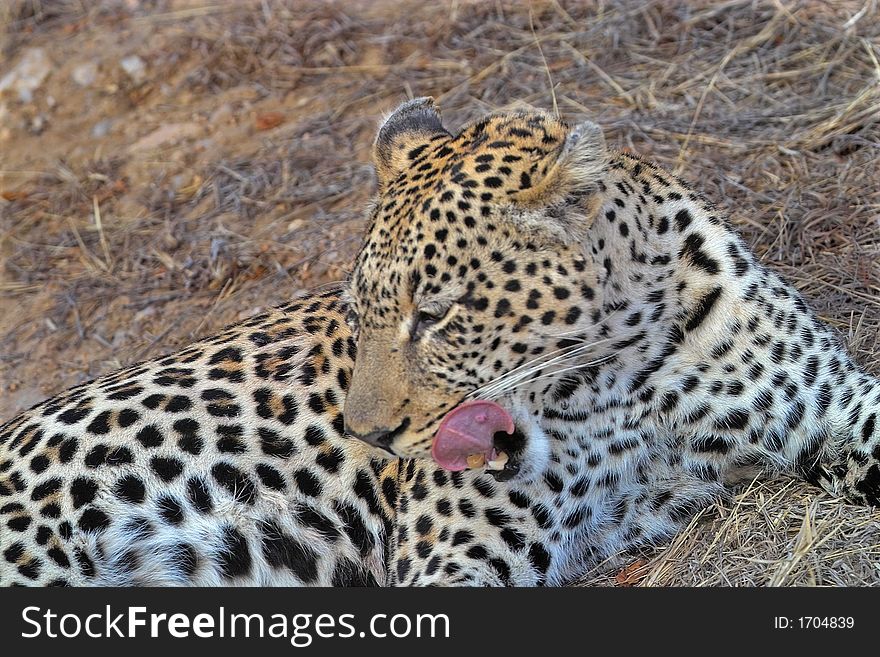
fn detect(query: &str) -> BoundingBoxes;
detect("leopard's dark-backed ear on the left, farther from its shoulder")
[373,98,451,189]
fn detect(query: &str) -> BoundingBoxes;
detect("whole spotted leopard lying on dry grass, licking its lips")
[0,98,880,586]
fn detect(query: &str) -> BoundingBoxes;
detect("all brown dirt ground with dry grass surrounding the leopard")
[0,0,880,585]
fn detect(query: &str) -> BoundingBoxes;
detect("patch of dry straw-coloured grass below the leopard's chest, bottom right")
[581,479,880,586]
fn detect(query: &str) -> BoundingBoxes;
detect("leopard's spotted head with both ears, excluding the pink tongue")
[344,98,607,476]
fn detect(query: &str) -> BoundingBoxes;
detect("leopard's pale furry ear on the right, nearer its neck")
[511,121,608,208]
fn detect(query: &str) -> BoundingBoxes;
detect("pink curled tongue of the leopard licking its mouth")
[431,400,514,471]
